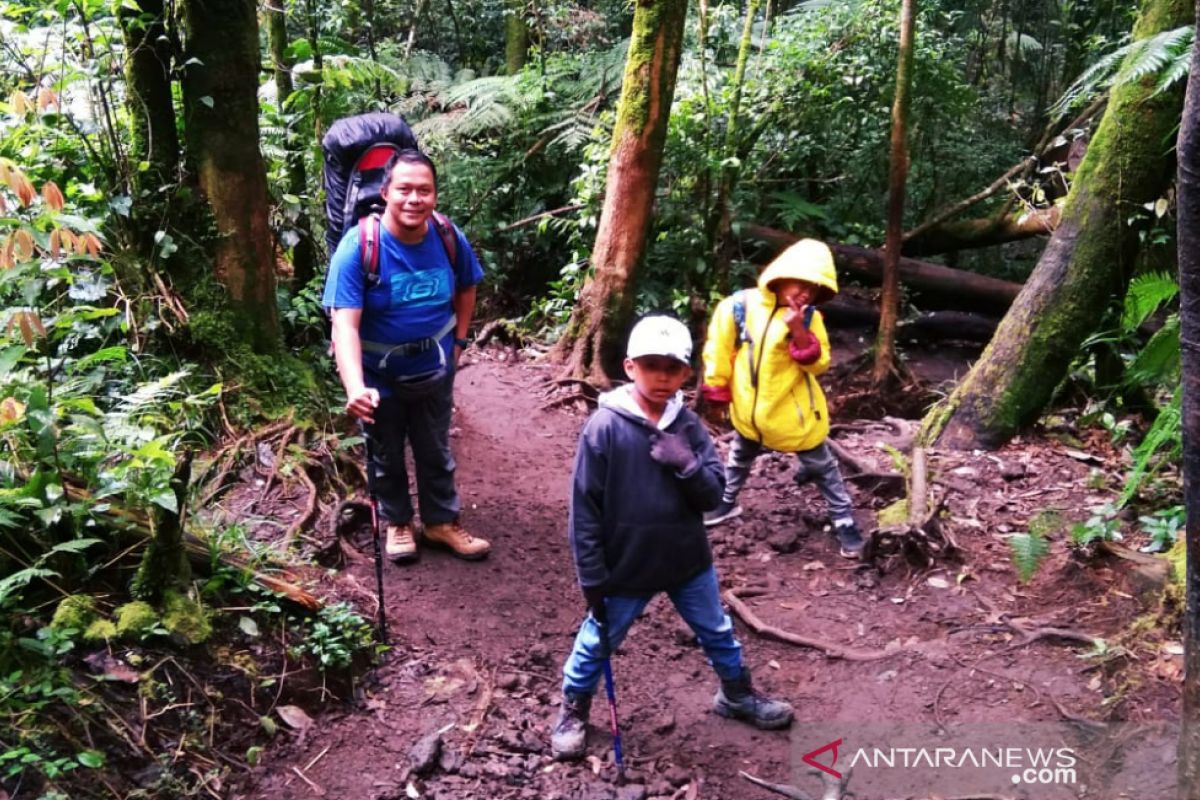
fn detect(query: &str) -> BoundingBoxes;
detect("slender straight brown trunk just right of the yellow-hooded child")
[871,0,916,389]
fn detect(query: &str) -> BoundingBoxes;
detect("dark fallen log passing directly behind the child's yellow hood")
[740,224,1021,313]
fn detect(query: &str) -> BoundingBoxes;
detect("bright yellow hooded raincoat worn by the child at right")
[704,239,838,452]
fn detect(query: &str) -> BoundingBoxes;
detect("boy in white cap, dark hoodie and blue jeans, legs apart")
[551,317,792,759]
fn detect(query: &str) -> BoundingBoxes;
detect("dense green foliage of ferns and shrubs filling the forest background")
[0,0,1194,796]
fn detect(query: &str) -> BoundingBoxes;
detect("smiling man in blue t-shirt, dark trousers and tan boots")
[322,150,491,563]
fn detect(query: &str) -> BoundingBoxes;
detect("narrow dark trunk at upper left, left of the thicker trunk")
[119,0,179,253]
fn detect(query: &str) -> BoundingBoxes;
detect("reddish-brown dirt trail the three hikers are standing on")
[235,360,1176,800]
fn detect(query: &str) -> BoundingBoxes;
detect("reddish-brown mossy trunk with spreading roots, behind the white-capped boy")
[556,0,688,384]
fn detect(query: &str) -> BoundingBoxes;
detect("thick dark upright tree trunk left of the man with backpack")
[184,0,278,351]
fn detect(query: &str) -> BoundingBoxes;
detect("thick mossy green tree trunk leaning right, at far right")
[923,0,1192,449]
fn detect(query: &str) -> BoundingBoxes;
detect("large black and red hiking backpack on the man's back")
[320,112,458,285]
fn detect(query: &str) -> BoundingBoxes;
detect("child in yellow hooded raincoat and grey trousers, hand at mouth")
[701,239,863,559]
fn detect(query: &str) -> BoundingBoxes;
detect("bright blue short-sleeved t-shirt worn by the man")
[322,222,484,389]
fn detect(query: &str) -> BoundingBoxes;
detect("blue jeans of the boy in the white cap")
[563,567,742,696]
